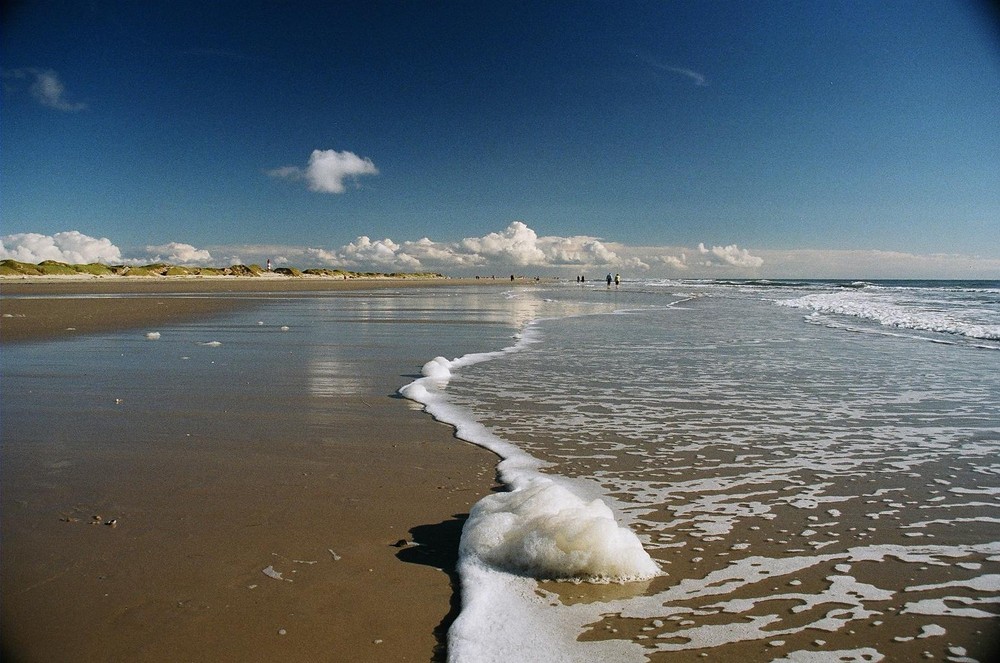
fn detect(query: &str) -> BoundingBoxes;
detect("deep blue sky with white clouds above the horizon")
[0,0,1000,278]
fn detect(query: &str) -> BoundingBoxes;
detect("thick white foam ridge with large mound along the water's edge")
[400,325,660,661]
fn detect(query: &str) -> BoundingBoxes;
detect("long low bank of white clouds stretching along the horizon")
[0,227,1000,280]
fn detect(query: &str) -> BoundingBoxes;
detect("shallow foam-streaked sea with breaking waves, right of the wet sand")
[400,280,1000,663]
